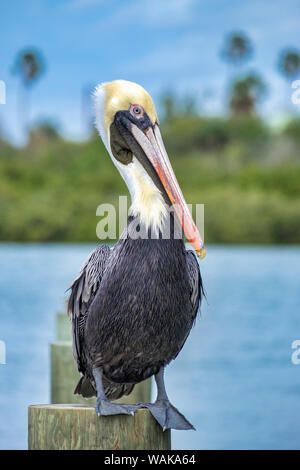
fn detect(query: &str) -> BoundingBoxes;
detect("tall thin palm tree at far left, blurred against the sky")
[13,48,45,132]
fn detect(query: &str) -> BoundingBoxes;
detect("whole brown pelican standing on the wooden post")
[68,80,205,429]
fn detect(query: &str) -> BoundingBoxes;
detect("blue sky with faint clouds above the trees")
[0,0,300,144]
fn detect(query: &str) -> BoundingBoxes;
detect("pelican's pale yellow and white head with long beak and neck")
[94,80,205,258]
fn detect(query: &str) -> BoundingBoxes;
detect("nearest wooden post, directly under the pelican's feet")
[28,405,171,450]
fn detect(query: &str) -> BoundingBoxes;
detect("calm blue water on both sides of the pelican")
[0,244,300,449]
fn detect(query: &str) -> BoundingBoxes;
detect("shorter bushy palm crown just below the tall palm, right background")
[230,74,266,115]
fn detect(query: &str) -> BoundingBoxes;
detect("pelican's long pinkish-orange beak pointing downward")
[130,122,206,259]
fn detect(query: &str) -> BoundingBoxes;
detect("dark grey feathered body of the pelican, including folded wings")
[68,220,203,399]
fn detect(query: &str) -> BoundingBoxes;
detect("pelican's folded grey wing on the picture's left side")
[68,245,111,372]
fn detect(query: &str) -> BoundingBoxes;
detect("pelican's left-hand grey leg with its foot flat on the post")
[93,367,137,416]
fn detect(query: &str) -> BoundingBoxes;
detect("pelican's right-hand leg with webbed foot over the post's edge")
[140,367,195,431]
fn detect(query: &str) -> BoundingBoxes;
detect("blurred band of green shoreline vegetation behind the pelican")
[0,113,300,243]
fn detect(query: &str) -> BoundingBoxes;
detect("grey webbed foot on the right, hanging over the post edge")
[139,400,195,431]
